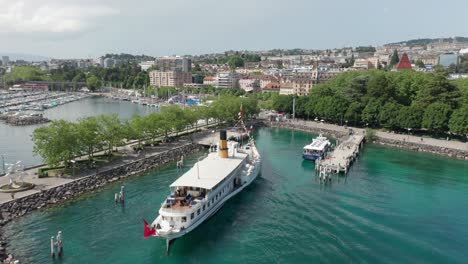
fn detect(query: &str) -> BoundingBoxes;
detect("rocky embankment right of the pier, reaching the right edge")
[374,137,468,160]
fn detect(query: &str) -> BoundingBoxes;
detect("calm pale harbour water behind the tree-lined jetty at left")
[0,97,157,167]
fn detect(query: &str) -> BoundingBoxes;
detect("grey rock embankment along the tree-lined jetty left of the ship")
[0,144,203,261]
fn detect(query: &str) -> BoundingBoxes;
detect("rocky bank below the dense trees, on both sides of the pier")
[264,122,468,160]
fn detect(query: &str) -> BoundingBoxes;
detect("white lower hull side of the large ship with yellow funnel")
[152,158,262,241]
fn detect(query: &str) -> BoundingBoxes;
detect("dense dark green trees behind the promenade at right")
[272,70,468,135]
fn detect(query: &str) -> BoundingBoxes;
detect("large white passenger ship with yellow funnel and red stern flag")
[145,129,261,253]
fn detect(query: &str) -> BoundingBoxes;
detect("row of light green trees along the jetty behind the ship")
[32,97,258,166]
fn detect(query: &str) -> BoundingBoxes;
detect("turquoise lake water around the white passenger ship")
[5,128,468,263]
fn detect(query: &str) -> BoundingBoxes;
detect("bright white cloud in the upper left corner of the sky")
[0,0,119,34]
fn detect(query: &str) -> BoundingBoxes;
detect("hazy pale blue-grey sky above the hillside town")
[0,0,468,58]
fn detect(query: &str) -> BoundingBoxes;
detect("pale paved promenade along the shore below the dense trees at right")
[291,120,468,152]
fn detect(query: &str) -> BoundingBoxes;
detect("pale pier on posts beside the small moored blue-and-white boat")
[315,134,364,180]
